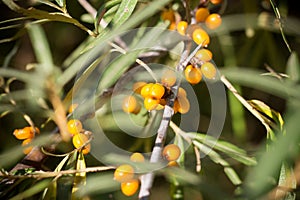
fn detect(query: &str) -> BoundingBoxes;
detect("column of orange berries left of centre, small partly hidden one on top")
[67,104,91,154]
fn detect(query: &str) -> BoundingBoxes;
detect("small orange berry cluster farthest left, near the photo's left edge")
[13,126,40,154]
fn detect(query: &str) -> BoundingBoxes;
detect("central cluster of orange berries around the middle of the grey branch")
[122,69,190,114]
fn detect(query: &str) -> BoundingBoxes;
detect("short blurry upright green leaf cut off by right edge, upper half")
[286,52,300,82]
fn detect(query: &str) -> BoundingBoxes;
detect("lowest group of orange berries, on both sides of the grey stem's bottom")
[114,144,181,196]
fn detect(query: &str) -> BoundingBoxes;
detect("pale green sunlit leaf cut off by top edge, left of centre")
[112,0,138,28]
